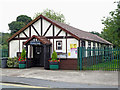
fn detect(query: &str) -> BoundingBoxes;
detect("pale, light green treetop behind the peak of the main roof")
[33,9,65,23]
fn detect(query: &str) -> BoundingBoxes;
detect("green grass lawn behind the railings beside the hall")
[83,60,120,71]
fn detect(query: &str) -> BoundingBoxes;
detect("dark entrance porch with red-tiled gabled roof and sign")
[24,35,52,69]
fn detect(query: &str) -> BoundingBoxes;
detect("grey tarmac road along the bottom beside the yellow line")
[2,76,118,88]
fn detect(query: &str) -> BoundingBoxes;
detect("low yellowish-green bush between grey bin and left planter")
[7,57,19,67]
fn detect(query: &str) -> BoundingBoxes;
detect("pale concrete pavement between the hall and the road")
[0,67,118,87]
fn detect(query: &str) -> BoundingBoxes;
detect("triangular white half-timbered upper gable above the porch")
[8,15,74,41]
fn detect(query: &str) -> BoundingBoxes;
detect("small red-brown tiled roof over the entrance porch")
[24,35,52,45]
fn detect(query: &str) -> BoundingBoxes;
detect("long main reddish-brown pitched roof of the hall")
[8,15,111,44]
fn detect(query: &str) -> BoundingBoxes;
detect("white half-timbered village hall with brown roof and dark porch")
[8,15,112,69]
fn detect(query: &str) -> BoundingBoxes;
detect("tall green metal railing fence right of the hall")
[78,47,120,71]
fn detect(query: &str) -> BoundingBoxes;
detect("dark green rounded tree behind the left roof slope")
[8,15,32,34]
